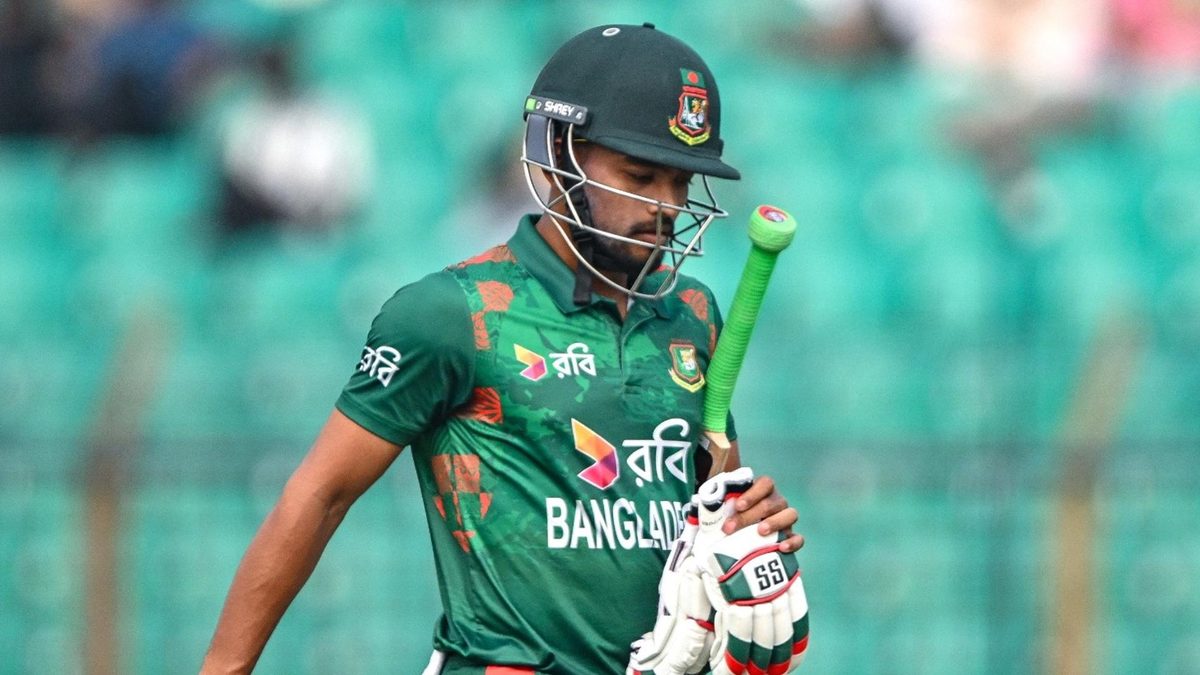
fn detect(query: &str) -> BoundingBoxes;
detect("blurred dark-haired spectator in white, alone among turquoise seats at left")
[218,46,373,233]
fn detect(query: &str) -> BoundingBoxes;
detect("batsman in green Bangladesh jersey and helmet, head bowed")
[205,24,803,675]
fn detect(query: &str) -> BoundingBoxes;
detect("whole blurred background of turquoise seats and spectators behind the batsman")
[0,0,1200,675]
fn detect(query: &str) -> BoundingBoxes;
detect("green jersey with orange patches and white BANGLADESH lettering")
[337,216,734,675]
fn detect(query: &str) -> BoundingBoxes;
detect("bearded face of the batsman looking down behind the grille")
[576,143,692,277]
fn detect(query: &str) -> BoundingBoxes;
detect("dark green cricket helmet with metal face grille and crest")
[521,24,740,304]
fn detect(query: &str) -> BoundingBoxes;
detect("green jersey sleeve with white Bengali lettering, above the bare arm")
[336,273,475,446]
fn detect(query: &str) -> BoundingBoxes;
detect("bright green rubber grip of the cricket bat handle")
[703,205,796,434]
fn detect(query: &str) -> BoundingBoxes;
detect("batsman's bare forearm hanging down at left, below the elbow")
[202,485,346,675]
